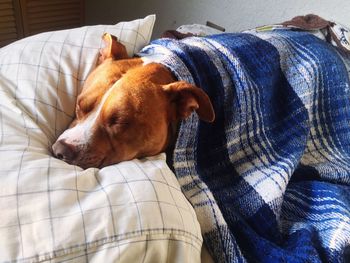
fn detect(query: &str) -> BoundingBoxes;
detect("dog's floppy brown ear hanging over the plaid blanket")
[163,81,215,122]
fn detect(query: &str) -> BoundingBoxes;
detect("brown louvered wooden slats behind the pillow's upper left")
[0,0,84,47]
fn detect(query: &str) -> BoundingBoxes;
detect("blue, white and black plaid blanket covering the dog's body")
[141,30,350,263]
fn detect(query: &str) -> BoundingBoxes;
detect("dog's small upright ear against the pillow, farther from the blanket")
[97,33,128,65]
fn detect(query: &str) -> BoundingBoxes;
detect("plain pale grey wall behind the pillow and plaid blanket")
[86,0,350,38]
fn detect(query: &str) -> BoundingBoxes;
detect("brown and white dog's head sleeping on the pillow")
[52,34,215,169]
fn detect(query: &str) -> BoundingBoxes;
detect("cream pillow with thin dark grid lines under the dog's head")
[0,15,202,262]
